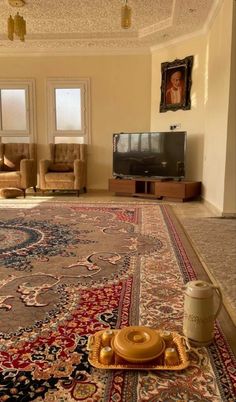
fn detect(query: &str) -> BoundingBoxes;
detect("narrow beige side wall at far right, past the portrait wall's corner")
[203,0,233,212]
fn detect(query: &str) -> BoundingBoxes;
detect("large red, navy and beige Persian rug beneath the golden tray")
[0,202,236,402]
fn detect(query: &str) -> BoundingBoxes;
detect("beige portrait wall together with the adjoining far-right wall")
[151,0,236,214]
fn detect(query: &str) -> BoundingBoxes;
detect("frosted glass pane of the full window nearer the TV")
[55,88,81,131]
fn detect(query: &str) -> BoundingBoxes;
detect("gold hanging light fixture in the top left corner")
[7,0,26,42]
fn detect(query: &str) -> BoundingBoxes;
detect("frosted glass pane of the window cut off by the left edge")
[1,89,27,131]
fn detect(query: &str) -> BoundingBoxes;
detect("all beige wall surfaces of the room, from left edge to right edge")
[1,1,236,214]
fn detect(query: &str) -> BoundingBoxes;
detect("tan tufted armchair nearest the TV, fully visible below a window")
[39,144,87,196]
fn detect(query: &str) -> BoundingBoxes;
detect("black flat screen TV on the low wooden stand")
[113,131,186,179]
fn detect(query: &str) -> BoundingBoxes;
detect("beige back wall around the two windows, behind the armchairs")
[0,55,151,189]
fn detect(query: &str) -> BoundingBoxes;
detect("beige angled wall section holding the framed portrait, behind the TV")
[151,36,206,180]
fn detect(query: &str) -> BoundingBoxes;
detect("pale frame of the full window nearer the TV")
[46,78,91,144]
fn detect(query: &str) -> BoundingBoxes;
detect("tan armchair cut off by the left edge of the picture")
[0,143,37,196]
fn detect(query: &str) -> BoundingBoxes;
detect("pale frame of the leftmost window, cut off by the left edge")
[0,78,36,143]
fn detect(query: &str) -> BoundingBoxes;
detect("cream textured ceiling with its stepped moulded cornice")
[0,0,223,57]
